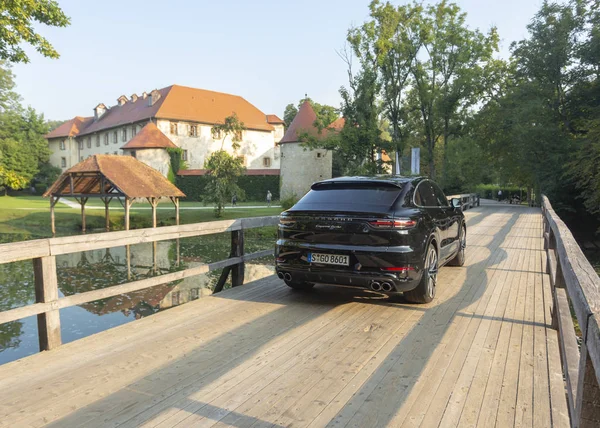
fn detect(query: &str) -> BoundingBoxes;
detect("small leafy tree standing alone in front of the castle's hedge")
[204,150,245,217]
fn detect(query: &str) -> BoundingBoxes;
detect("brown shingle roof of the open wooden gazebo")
[44,155,185,198]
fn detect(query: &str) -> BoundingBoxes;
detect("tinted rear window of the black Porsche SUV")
[294,183,402,212]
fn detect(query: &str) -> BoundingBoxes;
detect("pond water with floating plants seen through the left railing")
[0,227,275,364]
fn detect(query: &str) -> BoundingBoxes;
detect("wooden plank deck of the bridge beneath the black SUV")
[0,205,569,428]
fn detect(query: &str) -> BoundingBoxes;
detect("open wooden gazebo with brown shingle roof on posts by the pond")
[44,155,185,235]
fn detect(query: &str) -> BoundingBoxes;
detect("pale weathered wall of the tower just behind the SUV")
[281,143,332,199]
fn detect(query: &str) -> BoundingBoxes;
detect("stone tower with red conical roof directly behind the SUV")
[279,101,332,199]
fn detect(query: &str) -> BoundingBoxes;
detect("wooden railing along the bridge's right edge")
[542,195,600,427]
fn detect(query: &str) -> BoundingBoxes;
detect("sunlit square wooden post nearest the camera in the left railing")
[33,256,61,351]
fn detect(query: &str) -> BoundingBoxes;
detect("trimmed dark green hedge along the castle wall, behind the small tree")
[177,175,279,201]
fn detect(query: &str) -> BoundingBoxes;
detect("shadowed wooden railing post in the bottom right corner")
[571,338,600,428]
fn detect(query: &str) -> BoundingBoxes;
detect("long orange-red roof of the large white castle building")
[52,85,281,138]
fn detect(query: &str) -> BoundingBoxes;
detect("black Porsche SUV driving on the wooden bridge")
[275,177,467,303]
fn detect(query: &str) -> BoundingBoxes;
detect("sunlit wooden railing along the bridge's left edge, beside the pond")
[0,216,279,351]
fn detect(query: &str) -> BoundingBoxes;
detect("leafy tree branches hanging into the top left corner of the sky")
[0,0,71,63]
